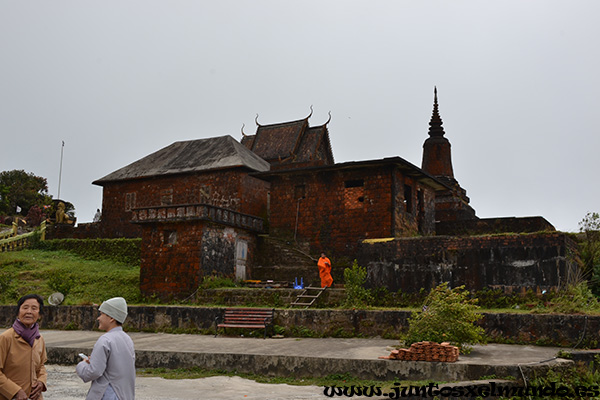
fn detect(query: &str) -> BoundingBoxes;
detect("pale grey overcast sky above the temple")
[0,0,600,231]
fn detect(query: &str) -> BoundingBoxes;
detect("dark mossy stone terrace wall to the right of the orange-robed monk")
[357,232,578,292]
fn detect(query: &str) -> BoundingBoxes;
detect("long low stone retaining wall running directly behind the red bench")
[0,306,600,348]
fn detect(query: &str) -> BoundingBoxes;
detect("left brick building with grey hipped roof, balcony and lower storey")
[94,136,269,298]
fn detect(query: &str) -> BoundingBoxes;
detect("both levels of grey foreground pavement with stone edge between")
[0,330,570,400]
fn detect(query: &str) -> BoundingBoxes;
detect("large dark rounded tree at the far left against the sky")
[0,170,52,215]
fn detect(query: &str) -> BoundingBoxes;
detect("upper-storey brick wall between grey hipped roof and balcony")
[102,168,269,237]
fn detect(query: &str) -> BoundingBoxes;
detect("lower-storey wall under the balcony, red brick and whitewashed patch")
[140,221,256,299]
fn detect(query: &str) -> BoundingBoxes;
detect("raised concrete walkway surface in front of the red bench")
[42,330,559,365]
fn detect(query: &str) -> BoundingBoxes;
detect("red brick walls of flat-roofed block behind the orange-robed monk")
[269,166,434,255]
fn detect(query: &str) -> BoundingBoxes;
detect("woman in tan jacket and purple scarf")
[0,294,48,400]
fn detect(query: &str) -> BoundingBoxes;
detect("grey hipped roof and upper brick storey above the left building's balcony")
[93,136,269,237]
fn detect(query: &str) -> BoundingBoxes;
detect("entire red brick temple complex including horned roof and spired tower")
[88,90,564,298]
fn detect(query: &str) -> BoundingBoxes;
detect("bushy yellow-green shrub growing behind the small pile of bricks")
[404,282,485,353]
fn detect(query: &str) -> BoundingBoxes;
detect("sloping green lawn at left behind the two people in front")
[0,250,142,305]
